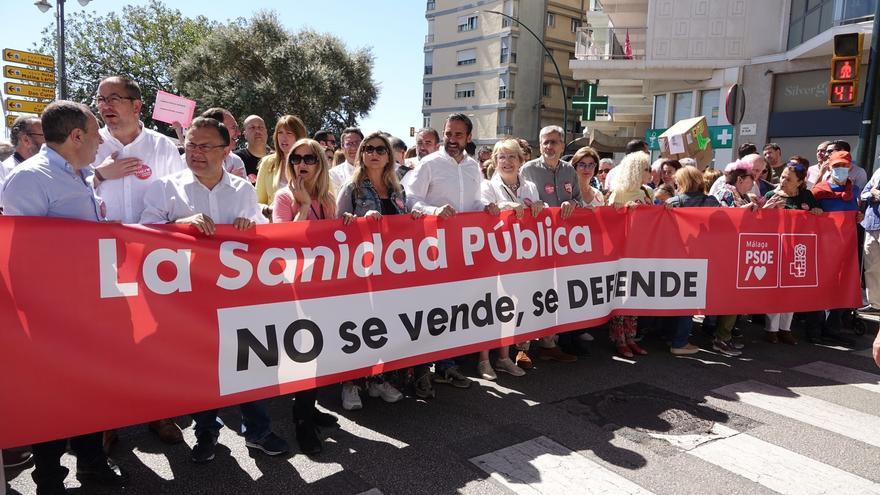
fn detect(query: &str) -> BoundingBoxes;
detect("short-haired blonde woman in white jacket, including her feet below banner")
[477,139,545,380]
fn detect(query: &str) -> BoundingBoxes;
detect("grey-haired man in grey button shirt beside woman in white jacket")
[520,125,581,363]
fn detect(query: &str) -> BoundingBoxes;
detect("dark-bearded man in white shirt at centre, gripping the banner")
[403,113,499,388]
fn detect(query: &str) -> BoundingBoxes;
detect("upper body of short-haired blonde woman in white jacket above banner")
[481,139,546,218]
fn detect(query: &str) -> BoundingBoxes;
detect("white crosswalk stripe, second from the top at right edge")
[713,380,880,447]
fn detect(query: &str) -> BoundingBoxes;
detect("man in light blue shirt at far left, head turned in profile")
[3,101,125,494]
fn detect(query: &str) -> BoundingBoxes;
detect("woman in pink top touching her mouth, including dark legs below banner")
[268,138,337,455]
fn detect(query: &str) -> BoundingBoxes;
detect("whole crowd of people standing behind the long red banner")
[0,76,880,494]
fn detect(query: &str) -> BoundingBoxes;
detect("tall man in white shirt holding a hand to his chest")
[92,76,186,226]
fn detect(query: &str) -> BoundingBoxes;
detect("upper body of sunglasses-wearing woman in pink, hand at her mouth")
[272,138,336,222]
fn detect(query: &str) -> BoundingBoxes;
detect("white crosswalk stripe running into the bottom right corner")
[688,433,880,495]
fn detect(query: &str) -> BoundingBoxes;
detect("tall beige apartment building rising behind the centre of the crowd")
[422,0,591,144]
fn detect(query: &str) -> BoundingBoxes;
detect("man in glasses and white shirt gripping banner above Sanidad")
[141,117,289,463]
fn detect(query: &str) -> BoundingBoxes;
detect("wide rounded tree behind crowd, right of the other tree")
[174,12,379,135]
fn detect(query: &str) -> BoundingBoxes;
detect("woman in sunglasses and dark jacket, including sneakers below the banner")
[336,132,424,411]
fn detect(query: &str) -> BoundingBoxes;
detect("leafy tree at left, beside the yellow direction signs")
[37,0,216,130]
